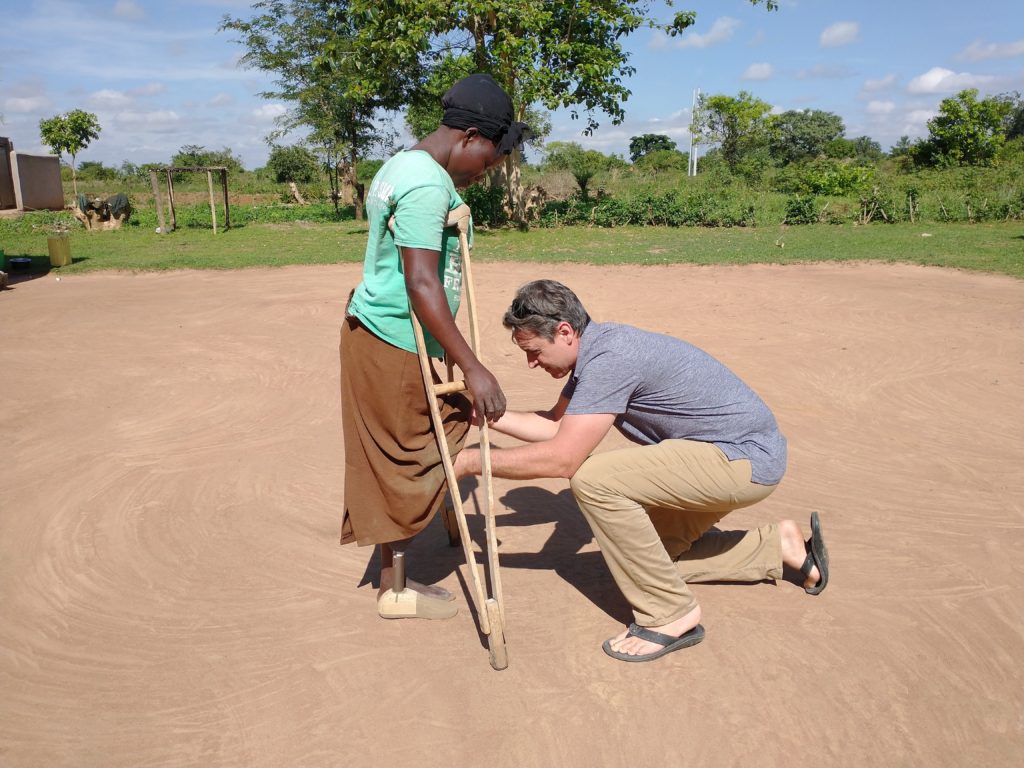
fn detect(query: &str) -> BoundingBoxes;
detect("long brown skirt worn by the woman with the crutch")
[340,316,471,546]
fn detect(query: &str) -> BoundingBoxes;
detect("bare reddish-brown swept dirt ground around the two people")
[0,261,1024,768]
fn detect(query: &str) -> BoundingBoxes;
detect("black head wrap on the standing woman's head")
[441,75,531,155]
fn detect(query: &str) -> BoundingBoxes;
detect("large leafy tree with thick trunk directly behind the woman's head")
[344,0,776,221]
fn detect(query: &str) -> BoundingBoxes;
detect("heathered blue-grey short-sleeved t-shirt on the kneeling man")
[562,323,786,485]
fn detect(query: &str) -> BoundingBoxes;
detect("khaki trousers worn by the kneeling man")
[570,440,782,627]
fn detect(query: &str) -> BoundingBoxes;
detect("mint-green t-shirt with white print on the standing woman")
[348,150,472,357]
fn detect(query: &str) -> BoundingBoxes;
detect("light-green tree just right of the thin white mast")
[690,91,771,171]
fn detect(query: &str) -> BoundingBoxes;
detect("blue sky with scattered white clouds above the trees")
[0,0,1024,168]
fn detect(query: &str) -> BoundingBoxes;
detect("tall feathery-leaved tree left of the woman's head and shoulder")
[220,0,405,217]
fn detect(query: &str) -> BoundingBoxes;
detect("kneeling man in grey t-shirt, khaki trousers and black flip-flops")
[456,280,828,662]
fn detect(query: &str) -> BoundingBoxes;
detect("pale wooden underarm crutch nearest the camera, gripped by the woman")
[410,206,509,670]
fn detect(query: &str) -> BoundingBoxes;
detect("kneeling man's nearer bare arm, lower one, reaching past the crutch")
[455,414,615,480]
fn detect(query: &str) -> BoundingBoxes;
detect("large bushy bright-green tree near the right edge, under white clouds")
[914,88,1013,166]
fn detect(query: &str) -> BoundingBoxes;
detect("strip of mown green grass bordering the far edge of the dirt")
[0,210,1024,278]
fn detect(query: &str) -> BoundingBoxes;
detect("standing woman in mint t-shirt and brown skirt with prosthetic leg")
[341,75,528,618]
